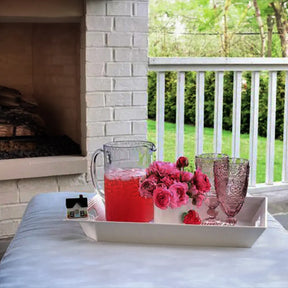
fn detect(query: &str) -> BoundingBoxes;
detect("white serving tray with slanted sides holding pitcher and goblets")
[73,197,267,247]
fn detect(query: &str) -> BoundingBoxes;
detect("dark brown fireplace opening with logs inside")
[0,23,81,159]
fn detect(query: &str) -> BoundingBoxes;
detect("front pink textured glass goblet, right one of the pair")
[214,158,249,225]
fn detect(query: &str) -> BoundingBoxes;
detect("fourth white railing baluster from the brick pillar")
[214,71,224,153]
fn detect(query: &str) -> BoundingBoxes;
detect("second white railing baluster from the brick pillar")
[176,72,185,159]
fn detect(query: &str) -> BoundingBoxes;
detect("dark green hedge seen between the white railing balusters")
[148,72,285,139]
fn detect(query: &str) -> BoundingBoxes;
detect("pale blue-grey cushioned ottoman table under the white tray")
[0,192,288,288]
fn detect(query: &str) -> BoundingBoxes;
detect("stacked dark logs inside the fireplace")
[0,86,45,137]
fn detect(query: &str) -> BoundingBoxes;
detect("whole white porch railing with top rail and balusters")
[149,58,288,191]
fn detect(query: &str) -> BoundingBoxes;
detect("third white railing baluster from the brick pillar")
[195,72,205,155]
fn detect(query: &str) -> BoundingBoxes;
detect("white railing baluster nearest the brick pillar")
[156,72,165,161]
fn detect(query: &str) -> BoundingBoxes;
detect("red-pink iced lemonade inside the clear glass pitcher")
[104,168,154,222]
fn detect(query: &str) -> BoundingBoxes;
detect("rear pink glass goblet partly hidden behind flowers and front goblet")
[195,153,229,225]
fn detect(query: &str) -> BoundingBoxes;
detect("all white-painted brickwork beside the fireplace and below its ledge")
[0,0,148,238]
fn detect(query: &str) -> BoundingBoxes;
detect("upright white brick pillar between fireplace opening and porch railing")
[86,0,148,153]
